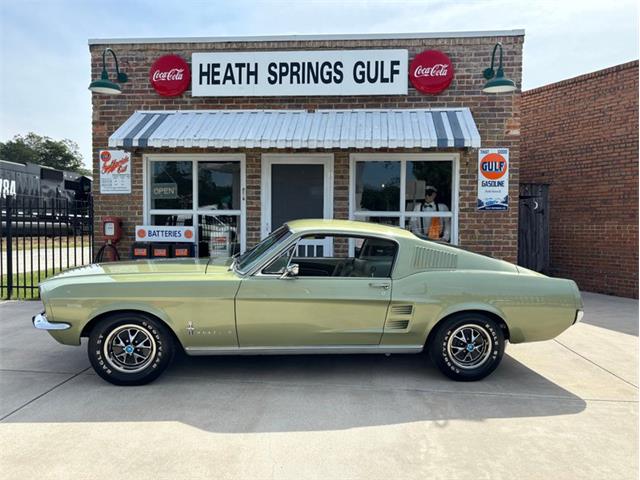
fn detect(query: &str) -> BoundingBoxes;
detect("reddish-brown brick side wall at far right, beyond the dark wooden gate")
[520,61,638,298]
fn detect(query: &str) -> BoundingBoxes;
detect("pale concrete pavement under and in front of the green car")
[0,293,638,480]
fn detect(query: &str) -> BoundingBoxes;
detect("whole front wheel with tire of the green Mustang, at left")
[88,312,174,385]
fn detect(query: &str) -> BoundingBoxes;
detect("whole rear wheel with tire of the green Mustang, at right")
[429,313,505,382]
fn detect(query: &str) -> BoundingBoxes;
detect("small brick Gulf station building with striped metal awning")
[89,31,524,261]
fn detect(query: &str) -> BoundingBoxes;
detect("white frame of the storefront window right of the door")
[349,152,460,245]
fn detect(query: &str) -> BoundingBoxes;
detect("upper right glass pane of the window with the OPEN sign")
[198,162,240,210]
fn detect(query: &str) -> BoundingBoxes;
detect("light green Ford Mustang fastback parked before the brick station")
[33,220,583,385]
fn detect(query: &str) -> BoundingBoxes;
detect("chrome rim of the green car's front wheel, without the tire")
[104,324,156,373]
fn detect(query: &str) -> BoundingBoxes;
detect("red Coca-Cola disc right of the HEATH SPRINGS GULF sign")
[409,50,453,94]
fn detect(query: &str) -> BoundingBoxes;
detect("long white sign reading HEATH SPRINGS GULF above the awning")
[191,49,409,97]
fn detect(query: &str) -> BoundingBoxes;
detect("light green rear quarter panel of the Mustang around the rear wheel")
[382,270,579,345]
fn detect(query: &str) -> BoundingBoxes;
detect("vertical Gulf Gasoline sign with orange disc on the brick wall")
[478,148,509,210]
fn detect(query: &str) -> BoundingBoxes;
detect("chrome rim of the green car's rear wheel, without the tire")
[447,323,493,370]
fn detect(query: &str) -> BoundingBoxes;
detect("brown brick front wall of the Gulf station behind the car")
[90,35,524,261]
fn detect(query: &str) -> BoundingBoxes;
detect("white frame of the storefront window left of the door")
[142,153,247,253]
